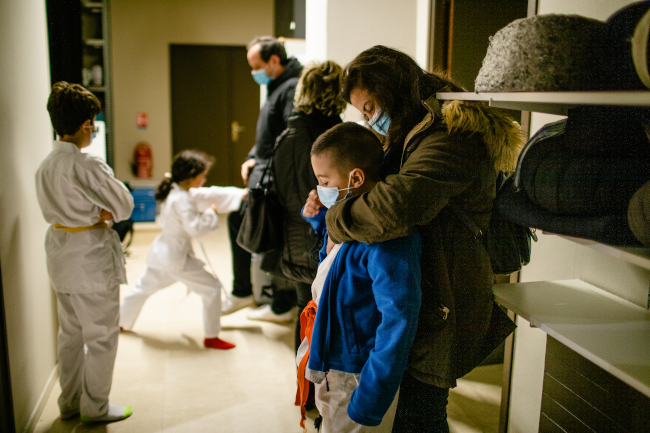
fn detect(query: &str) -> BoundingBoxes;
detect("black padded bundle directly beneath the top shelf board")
[517,107,650,216]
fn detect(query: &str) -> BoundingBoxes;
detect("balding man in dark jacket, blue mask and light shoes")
[222,36,302,322]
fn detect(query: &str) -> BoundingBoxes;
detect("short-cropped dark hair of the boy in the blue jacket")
[311,122,384,182]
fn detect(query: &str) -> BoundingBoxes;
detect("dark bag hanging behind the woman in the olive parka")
[448,173,537,275]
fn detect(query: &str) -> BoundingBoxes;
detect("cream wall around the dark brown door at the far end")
[111,0,274,181]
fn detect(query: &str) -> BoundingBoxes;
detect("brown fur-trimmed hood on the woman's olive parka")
[405,95,525,172]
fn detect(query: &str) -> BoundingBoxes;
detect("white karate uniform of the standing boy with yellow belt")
[36,141,133,417]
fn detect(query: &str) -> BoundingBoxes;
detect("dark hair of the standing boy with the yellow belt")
[47,81,101,137]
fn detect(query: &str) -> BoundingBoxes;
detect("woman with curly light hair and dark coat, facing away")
[273,61,346,350]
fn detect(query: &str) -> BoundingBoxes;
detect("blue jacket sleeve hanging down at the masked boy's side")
[348,234,422,426]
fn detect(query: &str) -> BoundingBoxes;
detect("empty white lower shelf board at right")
[493,280,650,396]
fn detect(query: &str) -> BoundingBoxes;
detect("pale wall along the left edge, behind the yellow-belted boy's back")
[0,0,57,432]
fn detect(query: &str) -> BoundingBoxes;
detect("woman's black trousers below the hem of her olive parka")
[393,372,449,433]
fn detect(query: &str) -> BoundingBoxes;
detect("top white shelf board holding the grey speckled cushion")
[436,90,650,116]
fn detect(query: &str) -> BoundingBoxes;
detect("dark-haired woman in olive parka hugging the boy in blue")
[326,46,523,433]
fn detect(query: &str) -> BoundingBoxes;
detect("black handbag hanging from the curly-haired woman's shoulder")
[237,158,282,254]
